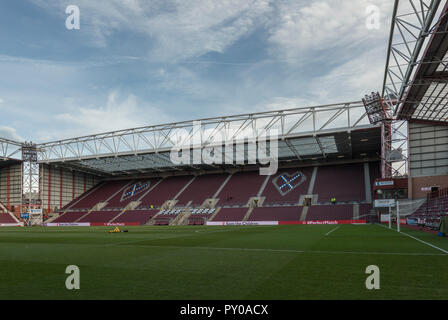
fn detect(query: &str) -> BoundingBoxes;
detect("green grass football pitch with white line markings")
[0,225,448,299]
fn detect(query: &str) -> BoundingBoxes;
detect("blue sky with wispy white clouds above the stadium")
[0,0,393,143]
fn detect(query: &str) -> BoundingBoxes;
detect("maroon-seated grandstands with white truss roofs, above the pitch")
[0,1,448,232]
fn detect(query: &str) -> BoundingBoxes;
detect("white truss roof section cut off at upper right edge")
[383,0,448,123]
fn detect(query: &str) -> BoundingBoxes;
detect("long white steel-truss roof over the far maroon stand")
[31,101,381,176]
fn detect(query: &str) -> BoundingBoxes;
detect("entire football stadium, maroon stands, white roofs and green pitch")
[0,0,448,300]
